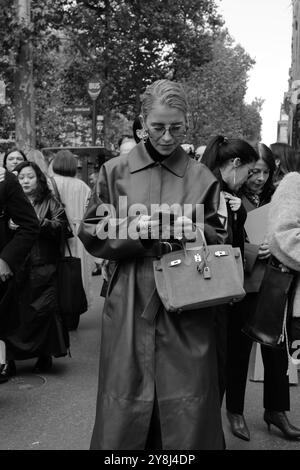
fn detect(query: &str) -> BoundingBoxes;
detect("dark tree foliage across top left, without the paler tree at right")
[0,0,222,147]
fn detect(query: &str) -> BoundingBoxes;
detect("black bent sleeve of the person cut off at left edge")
[0,172,39,271]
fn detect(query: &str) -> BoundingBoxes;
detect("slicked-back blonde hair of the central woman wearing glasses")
[141,80,188,120]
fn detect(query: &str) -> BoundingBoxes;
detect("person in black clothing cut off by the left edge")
[0,168,39,383]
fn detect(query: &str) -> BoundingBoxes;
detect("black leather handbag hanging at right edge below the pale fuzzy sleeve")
[242,256,295,348]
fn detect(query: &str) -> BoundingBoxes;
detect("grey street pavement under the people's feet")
[0,276,300,450]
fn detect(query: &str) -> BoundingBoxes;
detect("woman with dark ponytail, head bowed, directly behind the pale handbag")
[201,136,258,438]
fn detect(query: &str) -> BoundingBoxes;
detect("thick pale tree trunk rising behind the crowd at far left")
[14,0,35,152]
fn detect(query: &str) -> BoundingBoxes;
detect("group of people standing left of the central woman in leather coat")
[0,148,92,383]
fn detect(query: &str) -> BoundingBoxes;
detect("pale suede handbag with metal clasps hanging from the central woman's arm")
[153,231,246,313]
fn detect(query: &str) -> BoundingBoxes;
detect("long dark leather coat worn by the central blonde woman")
[79,143,225,450]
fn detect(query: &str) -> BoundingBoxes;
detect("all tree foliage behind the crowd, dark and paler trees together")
[0,0,261,150]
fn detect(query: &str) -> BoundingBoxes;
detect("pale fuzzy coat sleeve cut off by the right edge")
[268,173,300,271]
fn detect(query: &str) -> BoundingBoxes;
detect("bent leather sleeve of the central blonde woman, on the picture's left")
[78,165,150,260]
